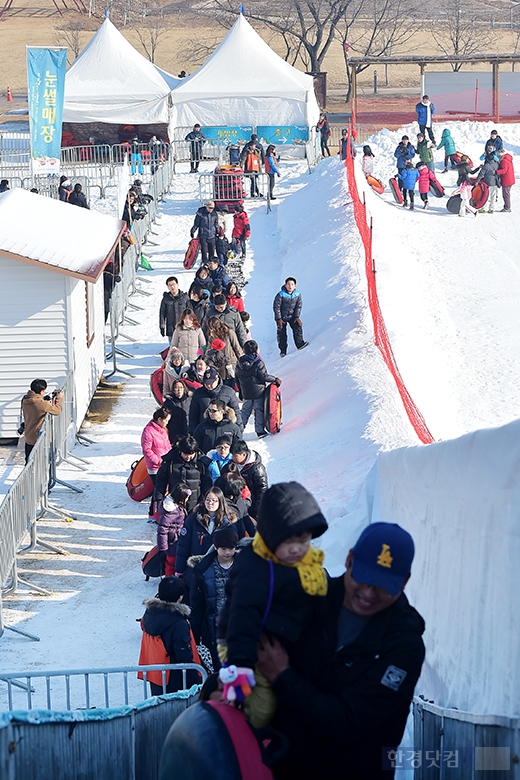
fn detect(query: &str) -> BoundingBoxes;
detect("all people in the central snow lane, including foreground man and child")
[133,143,424,780]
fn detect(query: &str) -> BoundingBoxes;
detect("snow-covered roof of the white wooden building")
[0,188,125,282]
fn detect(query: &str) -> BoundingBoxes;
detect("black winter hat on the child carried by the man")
[257,482,328,553]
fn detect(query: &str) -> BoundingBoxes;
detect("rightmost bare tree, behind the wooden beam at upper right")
[431,0,495,72]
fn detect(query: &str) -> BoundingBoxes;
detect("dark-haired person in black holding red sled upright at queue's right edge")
[236,339,282,439]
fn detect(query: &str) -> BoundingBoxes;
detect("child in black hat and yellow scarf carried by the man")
[218,482,327,728]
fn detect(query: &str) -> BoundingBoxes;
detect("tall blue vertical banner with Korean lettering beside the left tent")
[27,46,67,175]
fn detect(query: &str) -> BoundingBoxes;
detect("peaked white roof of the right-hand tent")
[172,14,314,103]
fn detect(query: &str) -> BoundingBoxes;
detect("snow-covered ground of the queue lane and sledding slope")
[0,122,520,720]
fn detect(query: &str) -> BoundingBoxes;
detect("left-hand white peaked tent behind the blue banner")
[63,19,180,125]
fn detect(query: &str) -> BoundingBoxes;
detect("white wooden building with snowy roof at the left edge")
[0,189,124,439]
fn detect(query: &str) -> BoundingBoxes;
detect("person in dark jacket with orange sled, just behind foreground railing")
[137,577,200,696]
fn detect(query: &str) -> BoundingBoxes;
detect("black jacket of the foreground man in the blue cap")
[272,577,424,780]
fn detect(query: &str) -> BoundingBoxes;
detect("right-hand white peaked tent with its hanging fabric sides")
[172,14,319,127]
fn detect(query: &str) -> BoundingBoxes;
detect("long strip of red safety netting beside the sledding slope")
[345,128,435,444]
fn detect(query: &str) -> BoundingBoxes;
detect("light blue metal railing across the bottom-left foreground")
[0,663,207,712]
